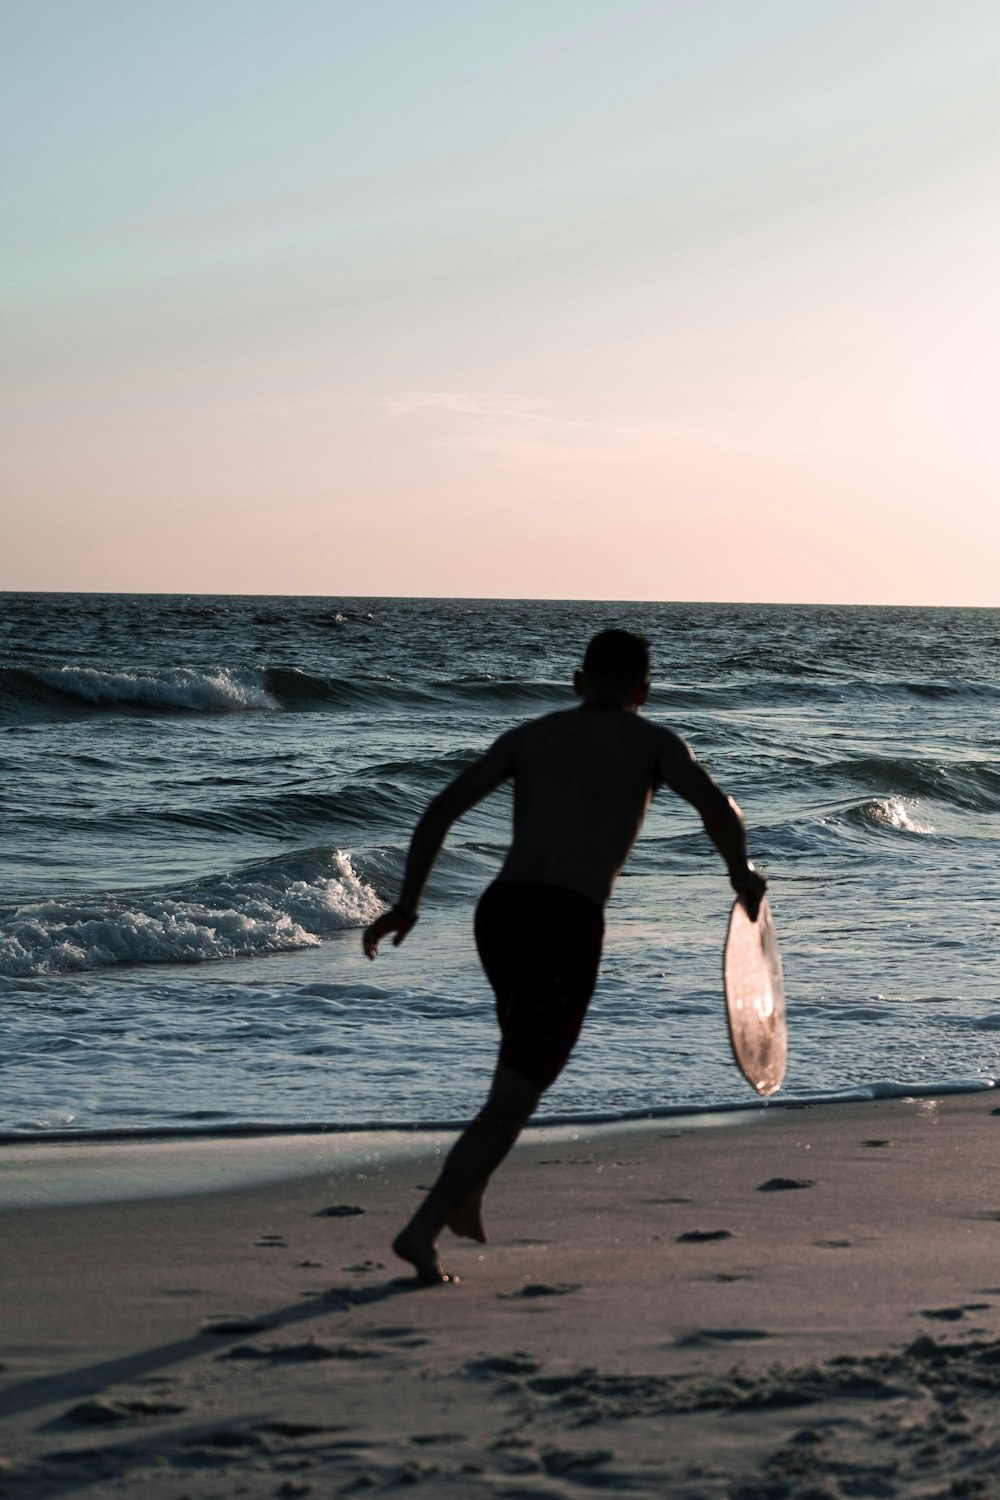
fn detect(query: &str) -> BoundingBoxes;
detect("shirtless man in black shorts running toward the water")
[364,630,766,1281]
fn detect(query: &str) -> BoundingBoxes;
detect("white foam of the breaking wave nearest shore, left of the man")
[0,851,382,978]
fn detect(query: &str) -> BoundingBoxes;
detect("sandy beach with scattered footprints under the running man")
[0,1091,1000,1500]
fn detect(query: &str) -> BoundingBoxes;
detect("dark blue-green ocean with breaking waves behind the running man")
[0,594,1000,1139]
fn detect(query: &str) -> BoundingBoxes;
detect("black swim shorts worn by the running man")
[475,881,604,1089]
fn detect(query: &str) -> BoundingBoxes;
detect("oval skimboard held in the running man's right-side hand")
[723,896,789,1098]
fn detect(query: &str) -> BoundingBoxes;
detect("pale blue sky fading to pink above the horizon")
[0,0,1000,606]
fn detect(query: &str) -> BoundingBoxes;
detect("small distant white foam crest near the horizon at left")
[36,666,277,713]
